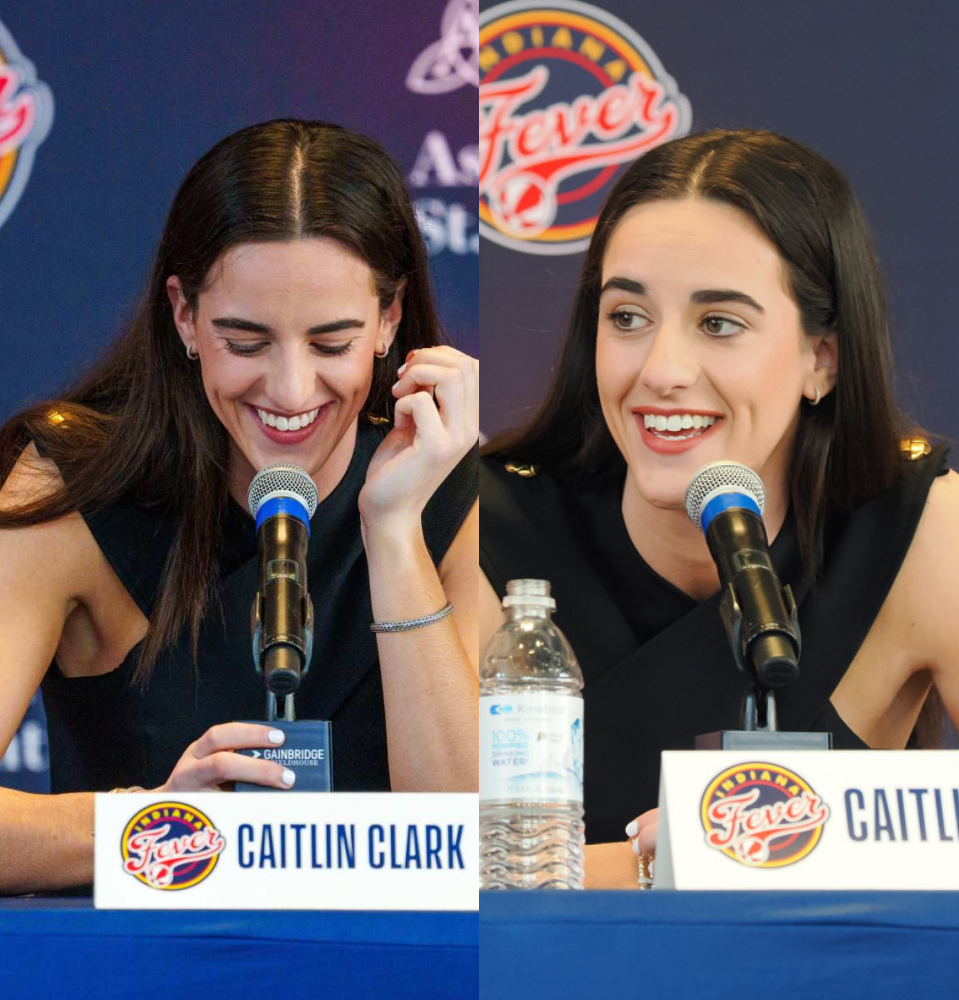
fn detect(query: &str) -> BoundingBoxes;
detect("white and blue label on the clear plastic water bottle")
[480,691,583,802]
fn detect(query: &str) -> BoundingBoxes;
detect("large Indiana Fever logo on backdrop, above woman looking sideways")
[479,0,691,254]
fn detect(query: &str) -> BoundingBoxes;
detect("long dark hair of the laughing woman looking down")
[0,119,445,683]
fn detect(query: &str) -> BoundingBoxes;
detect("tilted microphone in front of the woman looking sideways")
[686,462,800,688]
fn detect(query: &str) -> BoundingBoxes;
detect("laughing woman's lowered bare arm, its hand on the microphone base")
[0,446,310,895]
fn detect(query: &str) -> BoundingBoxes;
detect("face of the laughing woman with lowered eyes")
[168,238,400,496]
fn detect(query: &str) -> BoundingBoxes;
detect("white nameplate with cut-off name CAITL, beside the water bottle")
[655,750,959,890]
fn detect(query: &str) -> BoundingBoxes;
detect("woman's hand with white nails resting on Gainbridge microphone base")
[154,722,296,792]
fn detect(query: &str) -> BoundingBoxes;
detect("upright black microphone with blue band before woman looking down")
[247,465,317,700]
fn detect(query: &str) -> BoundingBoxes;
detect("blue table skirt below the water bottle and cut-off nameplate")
[480,896,959,1000]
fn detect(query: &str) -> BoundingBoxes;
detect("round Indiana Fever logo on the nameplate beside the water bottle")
[702,763,829,868]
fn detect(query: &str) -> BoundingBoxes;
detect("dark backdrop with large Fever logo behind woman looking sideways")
[479,0,959,440]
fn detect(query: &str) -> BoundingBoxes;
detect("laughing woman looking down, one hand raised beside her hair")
[0,120,478,892]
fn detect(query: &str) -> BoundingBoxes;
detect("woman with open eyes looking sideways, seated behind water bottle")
[480,131,959,886]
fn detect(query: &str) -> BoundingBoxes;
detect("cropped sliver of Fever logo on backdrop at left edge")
[0,23,53,226]
